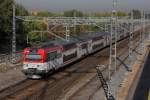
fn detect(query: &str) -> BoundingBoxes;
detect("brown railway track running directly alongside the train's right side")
[0,32,143,100]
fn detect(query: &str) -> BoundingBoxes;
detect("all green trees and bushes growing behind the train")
[0,0,141,51]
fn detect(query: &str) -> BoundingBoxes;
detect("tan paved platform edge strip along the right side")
[117,42,150,100]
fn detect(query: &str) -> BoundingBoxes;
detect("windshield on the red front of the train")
[25,54,42,61]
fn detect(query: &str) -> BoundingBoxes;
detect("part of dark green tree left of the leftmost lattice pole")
[0,0,13,43]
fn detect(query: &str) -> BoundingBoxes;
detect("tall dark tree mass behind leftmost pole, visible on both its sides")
[0,0,28,52]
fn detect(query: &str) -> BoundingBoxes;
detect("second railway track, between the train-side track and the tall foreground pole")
[61,33,142,100]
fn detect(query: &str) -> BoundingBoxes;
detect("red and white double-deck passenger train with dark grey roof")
[22,29,135,79]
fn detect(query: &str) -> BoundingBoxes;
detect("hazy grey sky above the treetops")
[16,0,150,12]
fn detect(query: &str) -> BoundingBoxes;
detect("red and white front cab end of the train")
[22,49,48,78]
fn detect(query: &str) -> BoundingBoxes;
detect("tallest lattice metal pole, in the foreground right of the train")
[108,0,117,98]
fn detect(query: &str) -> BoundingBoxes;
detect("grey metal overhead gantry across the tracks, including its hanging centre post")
[15,16,148,41]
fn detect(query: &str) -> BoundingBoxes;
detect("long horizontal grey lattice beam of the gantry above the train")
[16,16,150,23]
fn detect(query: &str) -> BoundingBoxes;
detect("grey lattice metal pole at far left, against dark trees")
[12,1,16,62]
